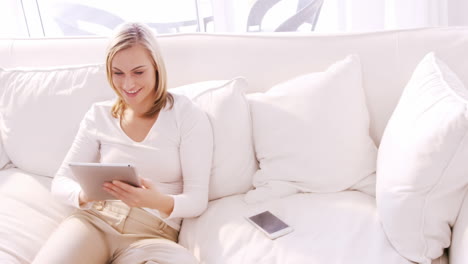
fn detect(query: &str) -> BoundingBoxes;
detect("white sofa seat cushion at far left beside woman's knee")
[0,169,71,264]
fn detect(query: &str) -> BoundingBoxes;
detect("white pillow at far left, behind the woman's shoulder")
[0,65,114,176]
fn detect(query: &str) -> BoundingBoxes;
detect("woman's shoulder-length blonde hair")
[106,22,174,118]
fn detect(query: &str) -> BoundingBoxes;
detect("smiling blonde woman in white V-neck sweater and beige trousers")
[33,23,213,264]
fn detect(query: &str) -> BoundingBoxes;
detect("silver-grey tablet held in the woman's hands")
[68,162,141,201]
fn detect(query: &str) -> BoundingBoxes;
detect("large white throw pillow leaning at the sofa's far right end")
[376,53,468,263]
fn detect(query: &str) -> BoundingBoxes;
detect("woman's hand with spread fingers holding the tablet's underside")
[103,178,174,215]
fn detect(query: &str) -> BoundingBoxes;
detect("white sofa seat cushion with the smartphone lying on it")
[179,191,411,264]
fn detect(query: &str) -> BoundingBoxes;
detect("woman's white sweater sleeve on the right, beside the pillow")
[168,98,213,219]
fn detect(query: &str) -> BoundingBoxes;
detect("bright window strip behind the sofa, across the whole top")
[0,0,468,38]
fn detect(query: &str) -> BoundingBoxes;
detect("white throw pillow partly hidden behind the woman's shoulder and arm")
[170,78,257,200]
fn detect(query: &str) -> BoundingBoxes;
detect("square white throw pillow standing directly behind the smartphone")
[246,55,377,202]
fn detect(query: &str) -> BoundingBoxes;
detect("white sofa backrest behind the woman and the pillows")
[0,28,468,144]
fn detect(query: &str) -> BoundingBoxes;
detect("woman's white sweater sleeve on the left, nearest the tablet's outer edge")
[51,106,99,208]
